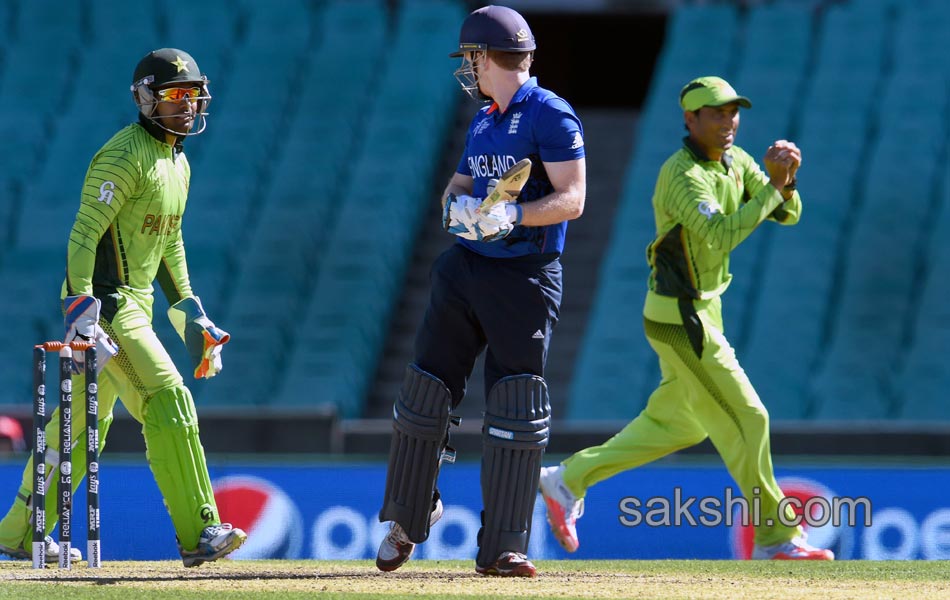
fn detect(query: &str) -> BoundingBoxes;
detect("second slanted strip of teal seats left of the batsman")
[229,2,386,412]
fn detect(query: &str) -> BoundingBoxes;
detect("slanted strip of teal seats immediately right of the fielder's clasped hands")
[740,0,884,419]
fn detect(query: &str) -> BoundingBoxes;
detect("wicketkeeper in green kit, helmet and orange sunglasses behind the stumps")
[0,48,247,567]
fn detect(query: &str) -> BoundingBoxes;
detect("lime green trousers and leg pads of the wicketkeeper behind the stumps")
[0,295,220,551]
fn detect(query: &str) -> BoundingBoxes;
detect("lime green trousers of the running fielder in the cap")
[563,298,800,545]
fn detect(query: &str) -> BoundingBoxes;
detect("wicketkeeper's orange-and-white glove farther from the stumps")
[168,296,231,379]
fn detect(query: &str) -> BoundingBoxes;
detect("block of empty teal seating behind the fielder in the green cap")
[569,0,950,420]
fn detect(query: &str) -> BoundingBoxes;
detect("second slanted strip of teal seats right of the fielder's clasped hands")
[813,0,948,418]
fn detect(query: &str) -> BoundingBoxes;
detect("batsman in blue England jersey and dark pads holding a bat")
[376,6,586,577]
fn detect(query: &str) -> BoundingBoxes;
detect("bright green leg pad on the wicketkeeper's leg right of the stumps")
[143,386,221,551]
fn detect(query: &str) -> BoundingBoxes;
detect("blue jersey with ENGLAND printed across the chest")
[456,77,584,258]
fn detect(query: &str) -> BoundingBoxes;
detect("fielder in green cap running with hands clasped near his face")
[540,77,834,560]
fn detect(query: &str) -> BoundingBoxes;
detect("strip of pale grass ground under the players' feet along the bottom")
[0,560,950,600]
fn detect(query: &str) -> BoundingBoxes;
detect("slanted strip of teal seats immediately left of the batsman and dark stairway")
[281,2,463,417]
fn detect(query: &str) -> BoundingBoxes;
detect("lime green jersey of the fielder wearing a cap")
[644,138,802,322]
